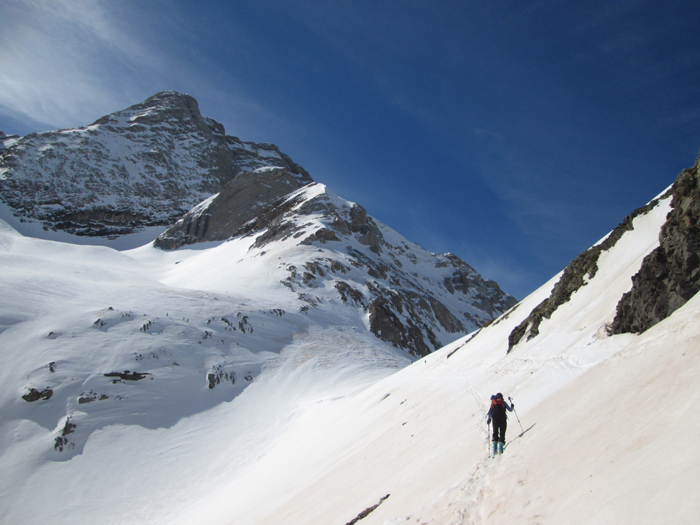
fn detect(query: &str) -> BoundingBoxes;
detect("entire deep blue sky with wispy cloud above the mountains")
[0,0,700,298]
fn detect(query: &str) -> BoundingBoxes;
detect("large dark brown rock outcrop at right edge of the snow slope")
[609,159,700,334]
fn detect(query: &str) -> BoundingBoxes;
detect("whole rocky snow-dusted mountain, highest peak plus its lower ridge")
[0,92,516,356]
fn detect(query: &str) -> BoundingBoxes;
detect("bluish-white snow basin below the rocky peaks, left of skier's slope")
[0,211,410,523]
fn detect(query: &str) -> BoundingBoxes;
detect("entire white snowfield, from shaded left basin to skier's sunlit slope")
[0,189,700,525]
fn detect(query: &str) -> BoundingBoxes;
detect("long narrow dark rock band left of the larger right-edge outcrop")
[508,188,658,352]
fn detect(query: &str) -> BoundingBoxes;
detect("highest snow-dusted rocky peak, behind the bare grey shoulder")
[0,91,308,238]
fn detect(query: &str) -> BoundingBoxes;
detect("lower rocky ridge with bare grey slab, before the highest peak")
[154,177,516,355]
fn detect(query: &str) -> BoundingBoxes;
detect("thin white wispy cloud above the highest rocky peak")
[0,0,171,127]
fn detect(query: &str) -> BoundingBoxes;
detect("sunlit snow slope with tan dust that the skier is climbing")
[164,161,700,524]
